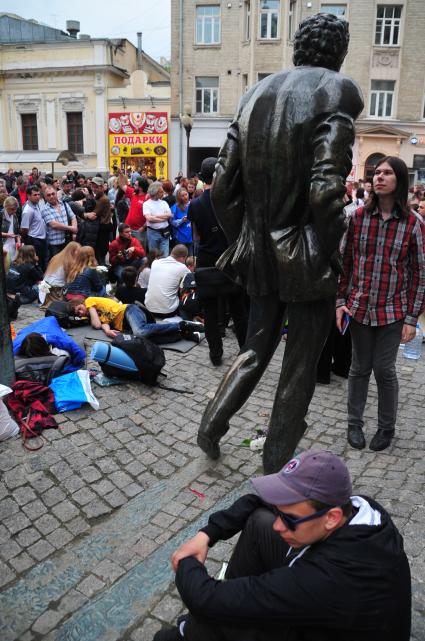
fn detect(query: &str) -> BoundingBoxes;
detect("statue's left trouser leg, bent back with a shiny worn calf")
[199,295,286,443]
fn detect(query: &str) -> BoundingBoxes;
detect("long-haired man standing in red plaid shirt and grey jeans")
[336,156,425,451]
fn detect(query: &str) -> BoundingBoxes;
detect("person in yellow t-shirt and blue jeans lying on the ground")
[70,296,204,343]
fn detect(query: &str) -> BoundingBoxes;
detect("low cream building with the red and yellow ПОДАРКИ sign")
[0,14,170,173]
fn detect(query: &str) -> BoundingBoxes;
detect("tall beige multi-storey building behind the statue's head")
[171,0,425,182]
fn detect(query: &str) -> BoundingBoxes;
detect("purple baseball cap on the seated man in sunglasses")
[251,450,352,506]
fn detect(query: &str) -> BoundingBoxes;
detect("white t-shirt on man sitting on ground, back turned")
[145,256,190,314]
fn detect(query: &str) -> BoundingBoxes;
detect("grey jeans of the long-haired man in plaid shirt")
[347,320,403,431]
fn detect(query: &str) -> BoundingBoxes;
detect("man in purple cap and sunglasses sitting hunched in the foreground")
[154,450,411,641]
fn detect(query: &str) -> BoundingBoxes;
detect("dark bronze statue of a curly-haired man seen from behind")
[198,8,363,474]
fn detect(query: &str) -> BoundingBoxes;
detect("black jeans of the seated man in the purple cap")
[184,508,288,641]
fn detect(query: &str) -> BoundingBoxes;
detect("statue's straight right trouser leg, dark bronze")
[263,297,335,474]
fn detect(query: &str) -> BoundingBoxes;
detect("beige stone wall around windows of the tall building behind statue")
[171,0,425,177]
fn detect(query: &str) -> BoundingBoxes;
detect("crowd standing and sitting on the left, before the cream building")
[0,159,237,348]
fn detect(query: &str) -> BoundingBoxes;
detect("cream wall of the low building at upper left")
[0,39,170,171]
